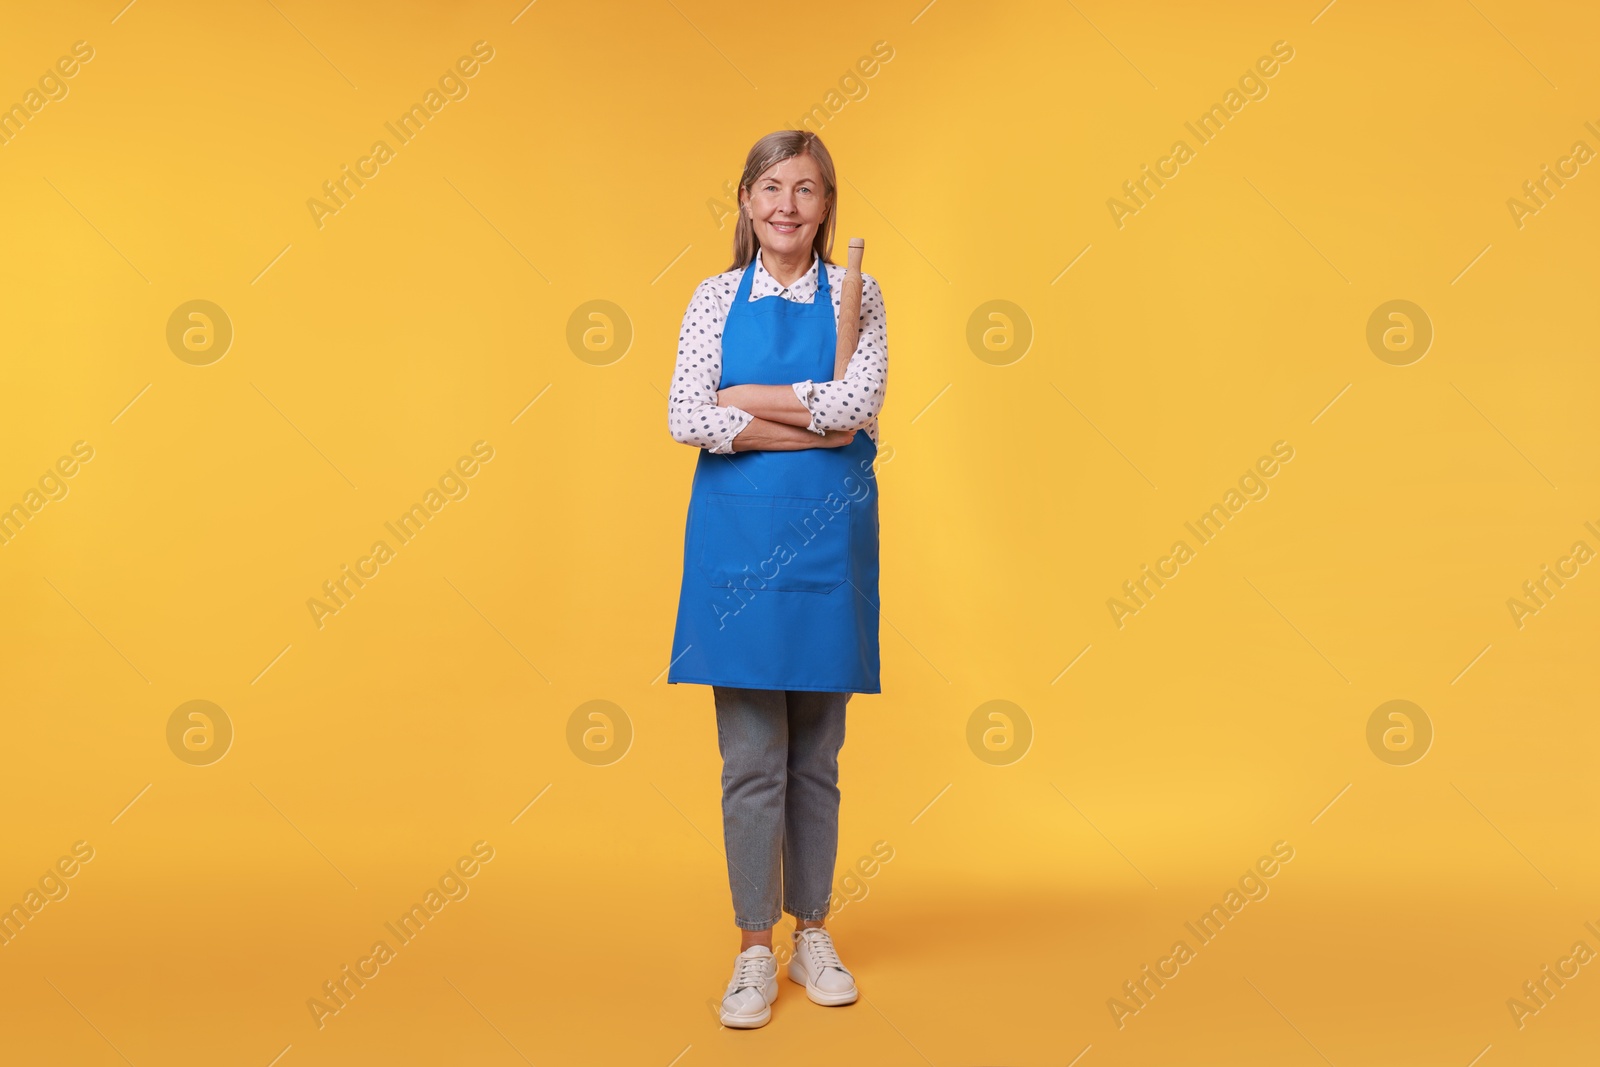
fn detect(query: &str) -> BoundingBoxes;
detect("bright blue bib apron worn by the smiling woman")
[667,251,882,693]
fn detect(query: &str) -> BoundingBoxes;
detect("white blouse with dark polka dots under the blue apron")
[667,253,890,453]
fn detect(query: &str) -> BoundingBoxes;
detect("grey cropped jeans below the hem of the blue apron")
[712,685,853,929]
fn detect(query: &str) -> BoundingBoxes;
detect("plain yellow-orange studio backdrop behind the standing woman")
[0,0,1600,1067]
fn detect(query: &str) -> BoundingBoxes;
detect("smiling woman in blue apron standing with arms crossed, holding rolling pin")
[667,130,888,1029]
